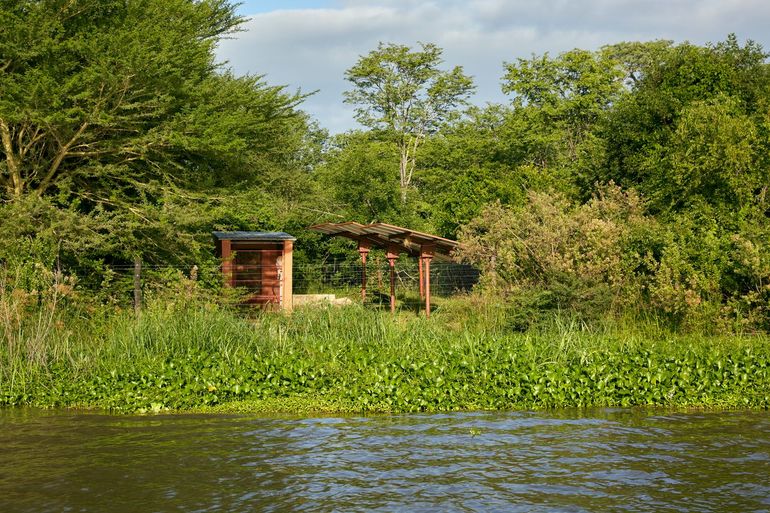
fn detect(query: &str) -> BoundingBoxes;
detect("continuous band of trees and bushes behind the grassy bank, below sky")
[0,0,770,331]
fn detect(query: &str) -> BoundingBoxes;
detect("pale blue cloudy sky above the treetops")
[217,0,770,133]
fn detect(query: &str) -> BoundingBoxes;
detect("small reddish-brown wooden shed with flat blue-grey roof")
[214,232,297,311]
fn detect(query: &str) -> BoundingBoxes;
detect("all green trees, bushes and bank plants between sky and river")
[0,0,770,411]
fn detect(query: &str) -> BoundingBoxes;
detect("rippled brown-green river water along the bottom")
[0,409,770,513]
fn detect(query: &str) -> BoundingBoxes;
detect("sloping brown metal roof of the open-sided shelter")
[310,222,460,260]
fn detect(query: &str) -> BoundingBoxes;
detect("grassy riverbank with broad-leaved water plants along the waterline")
[0,304,770,413]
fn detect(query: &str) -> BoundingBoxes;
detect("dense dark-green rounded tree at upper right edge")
[594,35,770,215]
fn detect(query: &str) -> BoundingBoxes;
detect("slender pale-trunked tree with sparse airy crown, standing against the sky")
[345,43,474,201]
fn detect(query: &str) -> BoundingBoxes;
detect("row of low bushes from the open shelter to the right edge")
[459,184,770,332]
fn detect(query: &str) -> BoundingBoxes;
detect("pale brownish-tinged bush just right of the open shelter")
[460,185,657,318]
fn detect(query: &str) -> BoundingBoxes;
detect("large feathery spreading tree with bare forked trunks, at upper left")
[0,0,307,262]
